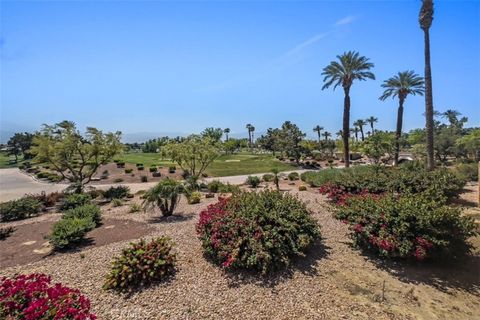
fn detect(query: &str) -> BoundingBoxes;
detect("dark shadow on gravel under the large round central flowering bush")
[225,241,331,289]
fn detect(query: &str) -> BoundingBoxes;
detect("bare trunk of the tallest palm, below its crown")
[424,29,435,170]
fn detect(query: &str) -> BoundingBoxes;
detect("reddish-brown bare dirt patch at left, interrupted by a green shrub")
[0,219,154,269]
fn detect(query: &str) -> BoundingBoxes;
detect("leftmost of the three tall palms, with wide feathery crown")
[322,51,375,167]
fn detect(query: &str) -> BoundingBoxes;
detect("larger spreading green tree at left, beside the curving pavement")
[31,121,122,193]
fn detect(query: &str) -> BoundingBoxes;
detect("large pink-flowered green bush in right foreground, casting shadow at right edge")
[335,194,475,260]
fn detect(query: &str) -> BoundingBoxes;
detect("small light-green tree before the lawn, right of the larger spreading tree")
[163,135,220,178]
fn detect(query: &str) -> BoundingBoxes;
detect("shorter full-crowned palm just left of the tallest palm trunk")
[379,70,425,166]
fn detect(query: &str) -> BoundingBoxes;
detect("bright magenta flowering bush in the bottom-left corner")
[0,274,96,320]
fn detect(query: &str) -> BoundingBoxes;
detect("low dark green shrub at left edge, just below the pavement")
[0,197,42,221]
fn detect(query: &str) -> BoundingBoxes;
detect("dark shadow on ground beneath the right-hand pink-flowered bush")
[356,246,480,294]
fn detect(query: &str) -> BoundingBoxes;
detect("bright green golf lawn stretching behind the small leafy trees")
[118,153,296,177]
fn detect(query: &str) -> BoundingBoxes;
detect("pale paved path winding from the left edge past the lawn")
[0,168,309,202]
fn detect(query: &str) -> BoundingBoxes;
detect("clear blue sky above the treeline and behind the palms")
[0,0,480,141]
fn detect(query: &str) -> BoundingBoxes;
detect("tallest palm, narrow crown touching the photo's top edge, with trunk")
[418,0,435,170]
